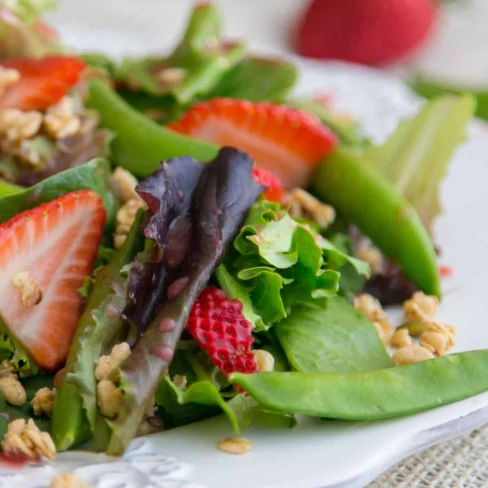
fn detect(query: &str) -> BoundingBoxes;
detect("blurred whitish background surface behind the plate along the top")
[49,0,488,86]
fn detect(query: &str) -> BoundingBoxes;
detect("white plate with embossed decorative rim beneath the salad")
[4,2,488,488]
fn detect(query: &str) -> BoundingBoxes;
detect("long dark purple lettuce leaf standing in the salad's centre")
[107,147,263,454]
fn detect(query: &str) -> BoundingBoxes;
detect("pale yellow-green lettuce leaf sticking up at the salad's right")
[364,95,476,234]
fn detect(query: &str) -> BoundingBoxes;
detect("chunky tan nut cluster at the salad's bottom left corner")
[2,419,56,460]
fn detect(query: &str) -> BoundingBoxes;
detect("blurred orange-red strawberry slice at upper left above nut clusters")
[0,56,85,110]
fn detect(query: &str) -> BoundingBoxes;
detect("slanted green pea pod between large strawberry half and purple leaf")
[51,211,144,451]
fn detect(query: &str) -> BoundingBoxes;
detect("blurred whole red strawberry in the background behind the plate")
[296,0,437,65]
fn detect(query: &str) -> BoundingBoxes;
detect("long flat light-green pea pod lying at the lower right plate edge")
[229,350,488,420]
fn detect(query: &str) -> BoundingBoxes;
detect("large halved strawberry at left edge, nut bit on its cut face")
[0,190,105,370]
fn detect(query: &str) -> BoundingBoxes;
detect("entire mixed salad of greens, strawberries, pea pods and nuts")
[0,0,480,472]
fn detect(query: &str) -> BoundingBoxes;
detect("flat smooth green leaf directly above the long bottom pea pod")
[273,296,393,373]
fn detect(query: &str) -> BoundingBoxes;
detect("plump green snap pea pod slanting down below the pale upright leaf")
[312,147,441,296]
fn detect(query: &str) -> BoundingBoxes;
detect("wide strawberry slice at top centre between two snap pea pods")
[169,98,337,188]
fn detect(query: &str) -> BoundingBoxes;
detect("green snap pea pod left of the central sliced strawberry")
[89,80,219,177]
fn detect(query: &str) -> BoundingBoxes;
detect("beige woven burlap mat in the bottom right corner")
[368,425,488,488]
